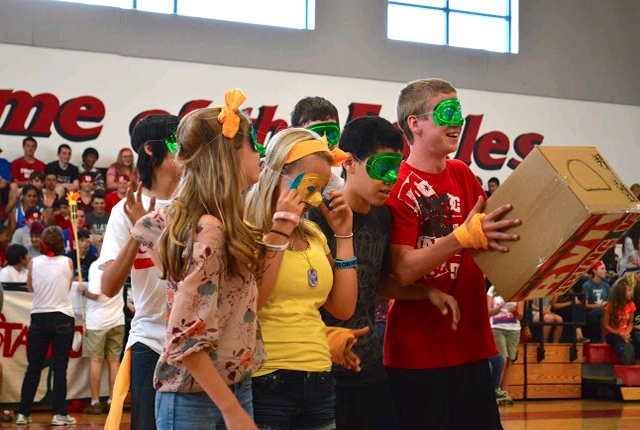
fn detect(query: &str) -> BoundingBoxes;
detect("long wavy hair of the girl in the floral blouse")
[158,108,266,280]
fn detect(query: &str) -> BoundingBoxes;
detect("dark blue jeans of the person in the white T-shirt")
[131,342,160,430]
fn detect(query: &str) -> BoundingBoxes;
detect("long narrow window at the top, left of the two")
[51,0,316,30]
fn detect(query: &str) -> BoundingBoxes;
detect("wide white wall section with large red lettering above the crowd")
[0,44,640,184]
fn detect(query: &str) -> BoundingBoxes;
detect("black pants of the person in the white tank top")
[19,312,74,416]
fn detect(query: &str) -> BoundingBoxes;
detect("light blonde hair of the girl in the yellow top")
[247,128,333,244]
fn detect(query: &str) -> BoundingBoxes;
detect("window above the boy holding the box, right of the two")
[387,0,518,53]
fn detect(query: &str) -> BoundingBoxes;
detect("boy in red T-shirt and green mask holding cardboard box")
[384,79,519,430]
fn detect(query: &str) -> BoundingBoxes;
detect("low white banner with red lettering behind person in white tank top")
[0,287,109,405]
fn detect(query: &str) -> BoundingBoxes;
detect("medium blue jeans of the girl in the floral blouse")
[156,378,253,430]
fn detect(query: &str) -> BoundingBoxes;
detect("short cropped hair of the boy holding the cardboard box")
[396,78,456,144]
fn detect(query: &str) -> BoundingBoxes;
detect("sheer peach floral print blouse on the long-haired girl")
[131,209,266,393]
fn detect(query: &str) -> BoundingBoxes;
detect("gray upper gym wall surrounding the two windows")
[0,0,640,105]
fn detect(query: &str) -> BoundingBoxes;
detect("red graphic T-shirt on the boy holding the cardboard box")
[384,160,498,369]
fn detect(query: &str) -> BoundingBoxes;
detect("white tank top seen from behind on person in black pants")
[31,255,74,317]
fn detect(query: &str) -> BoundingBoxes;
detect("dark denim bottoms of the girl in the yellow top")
[253,370,336,430]
